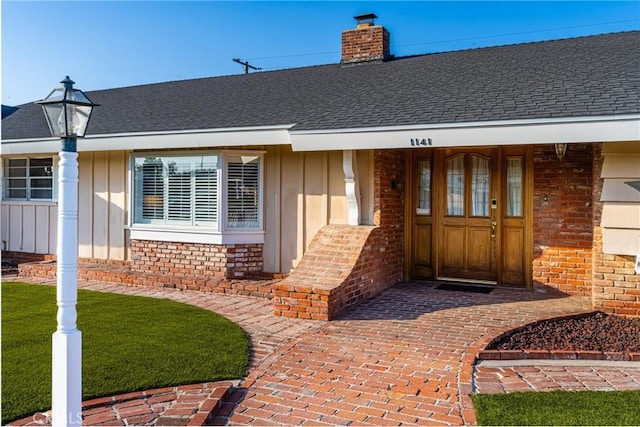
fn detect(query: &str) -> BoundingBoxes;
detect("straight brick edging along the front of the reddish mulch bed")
[476,350,640,362]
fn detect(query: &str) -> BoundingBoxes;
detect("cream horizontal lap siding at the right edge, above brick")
[600,141,640,255]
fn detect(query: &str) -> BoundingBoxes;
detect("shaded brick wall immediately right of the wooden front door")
[533,144,593,296]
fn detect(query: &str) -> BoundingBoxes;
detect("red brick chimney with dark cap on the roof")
[340,13,391,64]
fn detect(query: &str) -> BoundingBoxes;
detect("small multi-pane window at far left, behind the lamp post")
[3,157,54,200]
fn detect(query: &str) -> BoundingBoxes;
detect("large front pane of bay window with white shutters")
[134,155,220,226]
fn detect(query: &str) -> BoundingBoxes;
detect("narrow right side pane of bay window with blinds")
[227,156,260,228]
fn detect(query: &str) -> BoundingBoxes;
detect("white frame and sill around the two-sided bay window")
[127,150,265,244]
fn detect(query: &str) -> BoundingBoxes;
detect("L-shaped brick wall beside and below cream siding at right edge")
[593,144,640,317]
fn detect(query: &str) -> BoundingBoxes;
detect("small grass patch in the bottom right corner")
[472,391,640,426]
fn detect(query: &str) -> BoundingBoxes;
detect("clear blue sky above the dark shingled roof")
[0,0,640,105]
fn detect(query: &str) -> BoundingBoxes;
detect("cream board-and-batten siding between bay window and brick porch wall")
[263,146,373,273]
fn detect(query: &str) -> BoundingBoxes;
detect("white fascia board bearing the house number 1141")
[290,114,640,151]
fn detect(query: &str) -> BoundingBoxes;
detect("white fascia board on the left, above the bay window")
[2,124,294,155]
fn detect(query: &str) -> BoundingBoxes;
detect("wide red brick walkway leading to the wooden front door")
[217,283,590,425]
